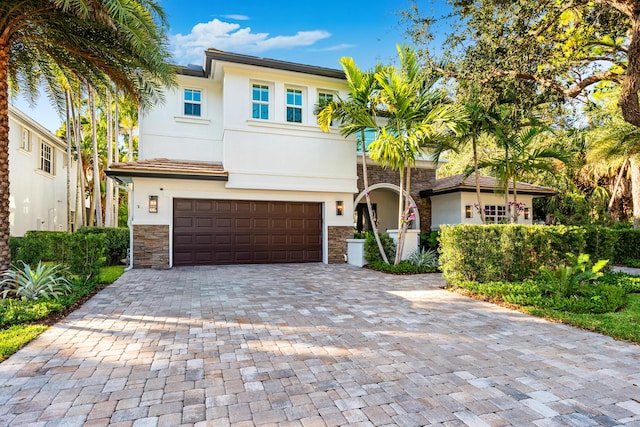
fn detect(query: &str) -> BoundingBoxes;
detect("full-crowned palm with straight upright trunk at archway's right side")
[370,46,465,265]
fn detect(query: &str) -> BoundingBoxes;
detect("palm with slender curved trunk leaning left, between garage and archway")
[318,57,389,264]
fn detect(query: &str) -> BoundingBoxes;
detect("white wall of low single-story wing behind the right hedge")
[431,192,533,230]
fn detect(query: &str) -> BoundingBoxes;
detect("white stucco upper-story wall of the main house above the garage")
[140,64,356,193]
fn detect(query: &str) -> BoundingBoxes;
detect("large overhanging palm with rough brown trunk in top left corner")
[0,0,175,269]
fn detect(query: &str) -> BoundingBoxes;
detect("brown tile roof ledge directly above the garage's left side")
[107,159,228,181]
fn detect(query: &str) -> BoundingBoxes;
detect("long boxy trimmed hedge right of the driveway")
[440,224,640,283]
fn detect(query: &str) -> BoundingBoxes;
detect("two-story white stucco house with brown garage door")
[107,49,552,268]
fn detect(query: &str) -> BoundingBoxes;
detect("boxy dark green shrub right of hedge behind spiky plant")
[69,233,105,278]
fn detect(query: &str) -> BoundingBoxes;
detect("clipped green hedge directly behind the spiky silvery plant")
[16,230,71,264]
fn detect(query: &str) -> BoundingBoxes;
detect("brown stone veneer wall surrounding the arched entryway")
[354,163,436,233]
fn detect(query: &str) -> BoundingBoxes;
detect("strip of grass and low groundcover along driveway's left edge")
[0,266,124,361]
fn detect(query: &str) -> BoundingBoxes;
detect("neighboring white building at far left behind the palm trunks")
[9,105,77,236]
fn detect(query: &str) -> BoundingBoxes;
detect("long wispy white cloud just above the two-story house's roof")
[171,18,331,65]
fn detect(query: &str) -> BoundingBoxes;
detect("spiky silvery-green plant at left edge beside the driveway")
[0,262,71,300]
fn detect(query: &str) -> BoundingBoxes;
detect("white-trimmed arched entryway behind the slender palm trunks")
[353,183,420,232]
